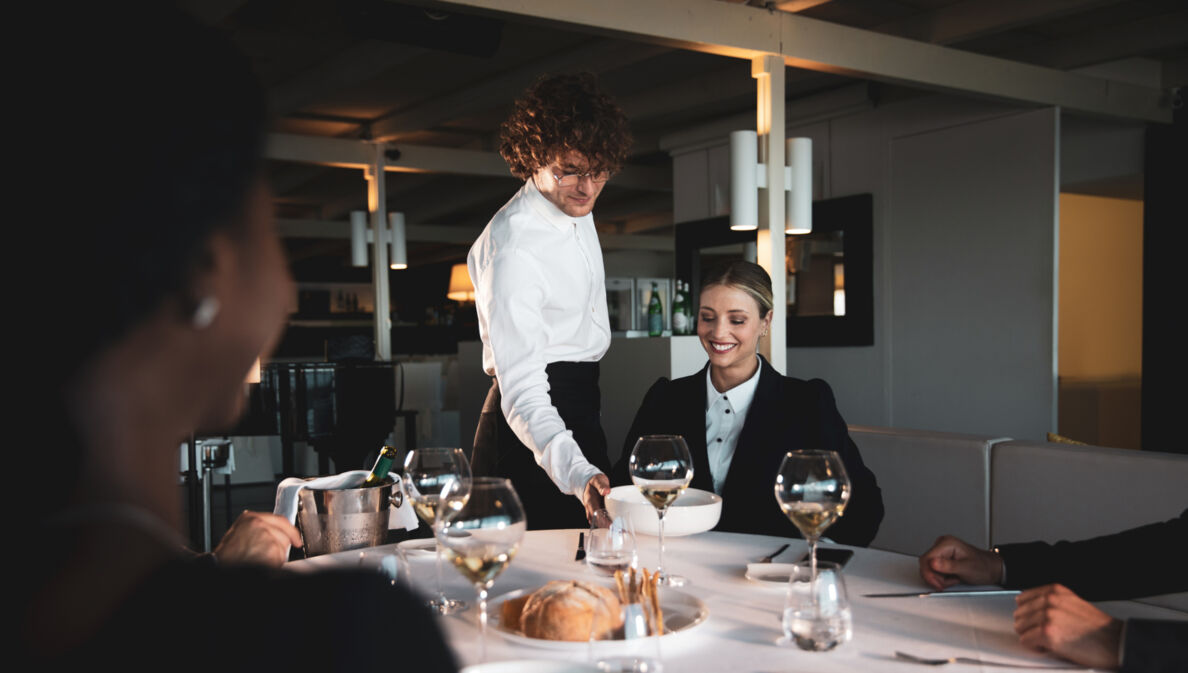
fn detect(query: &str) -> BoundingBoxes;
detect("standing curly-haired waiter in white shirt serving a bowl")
[467,73,631,528]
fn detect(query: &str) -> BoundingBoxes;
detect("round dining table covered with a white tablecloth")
[287,529,1186,673]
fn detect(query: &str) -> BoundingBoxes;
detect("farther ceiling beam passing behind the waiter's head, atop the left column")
[265,133,672,191]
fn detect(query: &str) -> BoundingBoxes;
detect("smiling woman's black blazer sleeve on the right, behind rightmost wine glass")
[809,378,883,547]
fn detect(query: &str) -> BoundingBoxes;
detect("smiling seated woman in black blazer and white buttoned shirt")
[614,260,883,546]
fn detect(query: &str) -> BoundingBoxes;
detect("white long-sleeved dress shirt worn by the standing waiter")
[467,178,611,495]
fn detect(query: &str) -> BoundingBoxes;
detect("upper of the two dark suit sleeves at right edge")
[998,510,1188,600]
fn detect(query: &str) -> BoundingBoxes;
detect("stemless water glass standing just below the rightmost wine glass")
[781,561,853,652]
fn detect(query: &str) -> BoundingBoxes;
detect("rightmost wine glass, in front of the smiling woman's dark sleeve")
[776,451,851,585]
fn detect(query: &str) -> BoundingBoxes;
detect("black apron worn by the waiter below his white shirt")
[470,363,611,529]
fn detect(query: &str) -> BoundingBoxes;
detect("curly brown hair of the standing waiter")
[499,73,631,180]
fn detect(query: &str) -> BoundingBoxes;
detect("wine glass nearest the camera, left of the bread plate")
[436,477,527,661]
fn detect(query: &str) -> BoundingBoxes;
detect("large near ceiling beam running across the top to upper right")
[425,0,1171,122]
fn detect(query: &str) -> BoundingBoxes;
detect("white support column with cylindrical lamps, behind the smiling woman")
[751,54,788,373]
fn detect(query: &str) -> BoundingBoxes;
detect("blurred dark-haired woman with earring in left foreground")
[15,4,454,671]
